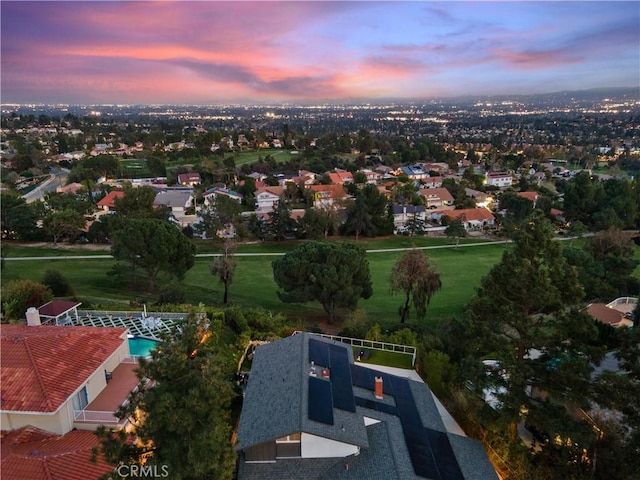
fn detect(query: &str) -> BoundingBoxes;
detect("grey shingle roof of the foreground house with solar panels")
[236,334,497,480]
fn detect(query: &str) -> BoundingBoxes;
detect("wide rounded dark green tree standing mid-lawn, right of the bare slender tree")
[272,241,373,321]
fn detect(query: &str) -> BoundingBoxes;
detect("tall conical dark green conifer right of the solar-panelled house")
[466,212,601,445]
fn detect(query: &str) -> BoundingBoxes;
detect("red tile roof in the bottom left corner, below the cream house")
[1,426,114,480]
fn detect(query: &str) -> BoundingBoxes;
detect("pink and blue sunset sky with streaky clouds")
[0,0,640,104]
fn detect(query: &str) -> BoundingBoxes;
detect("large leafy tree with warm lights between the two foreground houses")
[93,314,237,480]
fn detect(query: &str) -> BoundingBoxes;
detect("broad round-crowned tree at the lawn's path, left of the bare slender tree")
[111,218,195,291]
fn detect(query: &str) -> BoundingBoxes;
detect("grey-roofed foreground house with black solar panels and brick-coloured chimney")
[235,333,498,480]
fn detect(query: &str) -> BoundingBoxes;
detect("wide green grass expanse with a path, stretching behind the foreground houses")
[2,237,505,324]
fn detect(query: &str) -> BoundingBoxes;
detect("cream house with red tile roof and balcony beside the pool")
[0,320,138,435]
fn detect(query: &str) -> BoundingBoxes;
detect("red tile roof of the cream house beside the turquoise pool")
[0,325,127,412]
